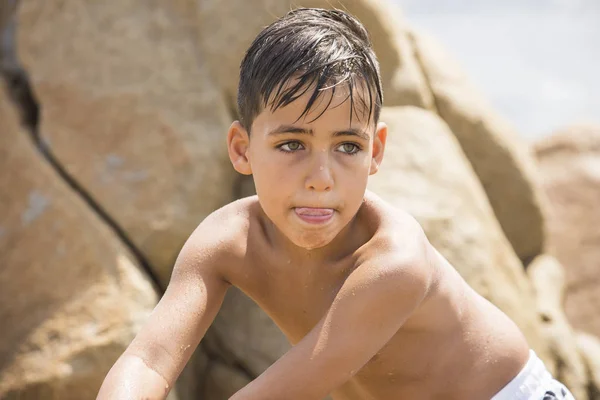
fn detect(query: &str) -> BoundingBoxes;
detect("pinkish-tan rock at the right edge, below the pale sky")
[535,126,600,335]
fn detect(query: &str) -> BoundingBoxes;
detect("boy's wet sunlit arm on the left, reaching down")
[97,228,229,400]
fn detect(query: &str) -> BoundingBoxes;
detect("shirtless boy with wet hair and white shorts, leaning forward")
[99,9,572,400]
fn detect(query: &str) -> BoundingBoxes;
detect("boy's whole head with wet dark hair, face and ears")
[228,8,387,252]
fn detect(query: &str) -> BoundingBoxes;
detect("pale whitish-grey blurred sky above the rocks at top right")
[389,0,600,141]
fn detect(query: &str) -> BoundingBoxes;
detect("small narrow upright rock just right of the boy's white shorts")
[527,255,588,400]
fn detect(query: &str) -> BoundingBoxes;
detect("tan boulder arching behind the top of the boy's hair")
[200,0,433,112]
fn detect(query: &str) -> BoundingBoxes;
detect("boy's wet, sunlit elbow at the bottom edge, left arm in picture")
[96,352,171,400]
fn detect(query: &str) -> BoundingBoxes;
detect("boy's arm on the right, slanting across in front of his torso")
[230,241,431,400]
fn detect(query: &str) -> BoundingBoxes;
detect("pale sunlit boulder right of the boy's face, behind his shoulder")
[368,107,551,361]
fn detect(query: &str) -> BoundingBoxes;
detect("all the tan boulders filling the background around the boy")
[0,0,600,400]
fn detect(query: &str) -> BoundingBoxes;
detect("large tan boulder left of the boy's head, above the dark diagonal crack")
[18,0,234,288]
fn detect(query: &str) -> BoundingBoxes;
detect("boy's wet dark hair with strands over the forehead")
[237,8,383,132]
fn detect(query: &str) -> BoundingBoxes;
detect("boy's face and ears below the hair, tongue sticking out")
[228,85,387,249]
